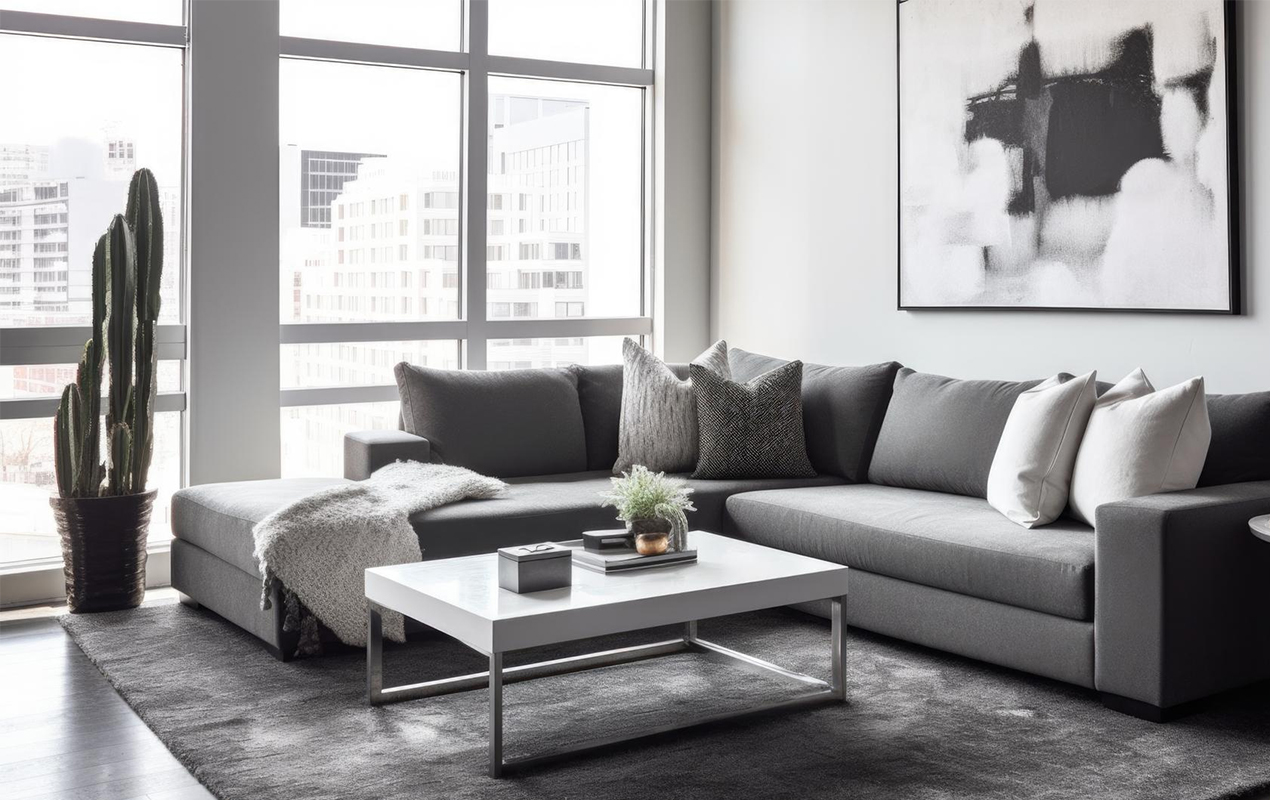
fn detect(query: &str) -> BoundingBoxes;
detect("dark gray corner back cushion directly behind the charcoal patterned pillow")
[728,348,899,483]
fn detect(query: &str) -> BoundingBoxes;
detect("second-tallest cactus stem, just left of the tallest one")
[105,215,137,495]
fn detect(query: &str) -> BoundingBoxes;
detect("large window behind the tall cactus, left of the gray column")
[0,6,185,570]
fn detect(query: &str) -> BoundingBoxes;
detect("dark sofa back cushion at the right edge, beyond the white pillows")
[1199,391,1270,486]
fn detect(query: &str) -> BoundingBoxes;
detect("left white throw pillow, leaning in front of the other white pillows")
[988,372,1097,528]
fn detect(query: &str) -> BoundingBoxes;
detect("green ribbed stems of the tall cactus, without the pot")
[53,169,163,498]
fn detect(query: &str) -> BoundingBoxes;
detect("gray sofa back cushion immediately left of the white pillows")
[869,367,1040,498]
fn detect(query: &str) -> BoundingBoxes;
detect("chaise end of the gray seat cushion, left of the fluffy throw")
[171,477,347,578]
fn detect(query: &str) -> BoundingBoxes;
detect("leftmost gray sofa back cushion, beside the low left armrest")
[394,362,587,477]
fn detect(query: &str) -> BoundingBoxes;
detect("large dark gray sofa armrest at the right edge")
[1093,481,1270,710]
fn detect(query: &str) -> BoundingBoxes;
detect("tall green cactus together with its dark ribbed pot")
[50,169,163,612]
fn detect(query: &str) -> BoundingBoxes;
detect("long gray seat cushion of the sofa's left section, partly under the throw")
[171,470,841,577]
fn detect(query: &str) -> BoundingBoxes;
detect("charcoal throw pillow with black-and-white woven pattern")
[691,361,815,479]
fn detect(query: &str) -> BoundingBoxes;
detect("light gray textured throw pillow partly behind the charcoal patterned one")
[613,339,732,472]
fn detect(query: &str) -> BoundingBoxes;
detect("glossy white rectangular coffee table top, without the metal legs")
[366,531,847,651]
